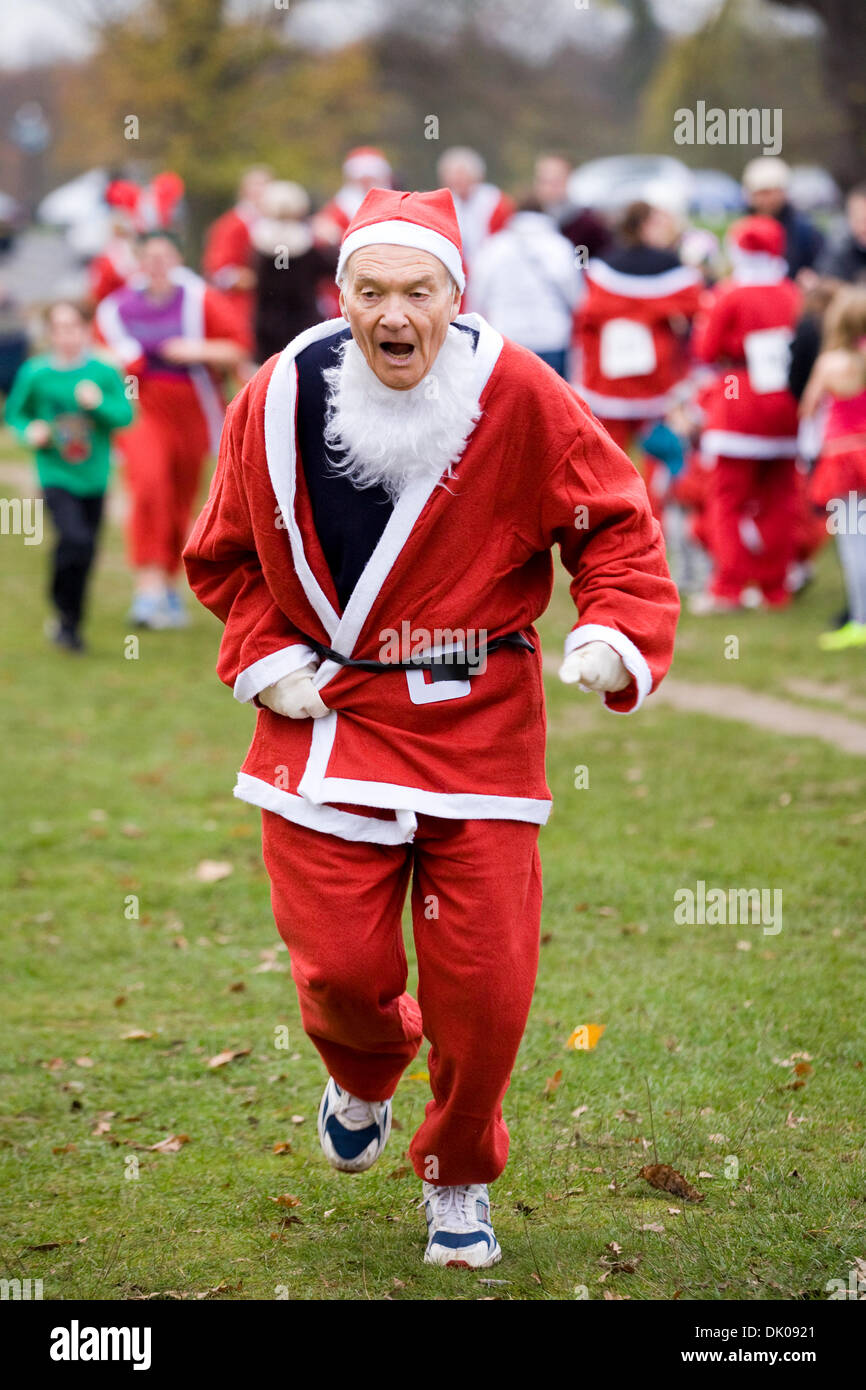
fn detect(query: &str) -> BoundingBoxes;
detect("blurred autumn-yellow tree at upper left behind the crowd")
[58,0,399,242]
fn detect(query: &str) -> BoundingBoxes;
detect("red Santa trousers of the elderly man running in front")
[261,810,542,1186]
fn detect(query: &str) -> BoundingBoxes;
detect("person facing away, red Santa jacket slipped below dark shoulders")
[578,202,703,494]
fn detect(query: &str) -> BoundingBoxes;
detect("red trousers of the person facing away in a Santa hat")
[708,457,799,606]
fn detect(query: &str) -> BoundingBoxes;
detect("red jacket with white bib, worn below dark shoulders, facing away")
[578,260,702,420]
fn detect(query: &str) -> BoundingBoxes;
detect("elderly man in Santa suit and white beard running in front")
[185,189,678,1266]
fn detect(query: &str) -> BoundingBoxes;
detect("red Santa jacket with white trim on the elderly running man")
[183,314,680,844]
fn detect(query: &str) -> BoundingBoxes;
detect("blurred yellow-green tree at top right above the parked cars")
[639,0,841,177]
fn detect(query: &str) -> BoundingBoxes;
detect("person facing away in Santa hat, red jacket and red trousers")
[692,217,801,613]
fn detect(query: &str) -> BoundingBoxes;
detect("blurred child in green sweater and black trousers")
[6,302,132,652]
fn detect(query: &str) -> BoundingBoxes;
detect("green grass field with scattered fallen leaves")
[0,442,866,1301]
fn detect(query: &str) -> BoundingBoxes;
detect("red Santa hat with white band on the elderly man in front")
[336,188,466,292]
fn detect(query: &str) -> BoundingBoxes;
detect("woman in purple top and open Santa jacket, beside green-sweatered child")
[96,232,247,628]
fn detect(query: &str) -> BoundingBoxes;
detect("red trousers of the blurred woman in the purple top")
[118,377,210,574]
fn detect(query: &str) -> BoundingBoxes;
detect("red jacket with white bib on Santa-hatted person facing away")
[692,277,801,459]
